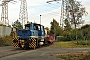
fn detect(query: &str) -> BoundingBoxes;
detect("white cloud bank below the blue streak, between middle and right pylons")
[29,8,60,27]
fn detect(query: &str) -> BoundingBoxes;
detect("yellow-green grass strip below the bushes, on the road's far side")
[52,41,90,48]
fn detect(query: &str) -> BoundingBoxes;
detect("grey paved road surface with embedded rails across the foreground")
[0,45,90,60]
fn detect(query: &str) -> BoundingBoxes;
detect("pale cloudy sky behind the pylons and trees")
[0,0,90,27]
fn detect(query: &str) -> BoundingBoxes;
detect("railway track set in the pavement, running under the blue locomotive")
[0,45,49,58]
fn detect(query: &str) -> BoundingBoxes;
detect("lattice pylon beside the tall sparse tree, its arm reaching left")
[47,0,69,28]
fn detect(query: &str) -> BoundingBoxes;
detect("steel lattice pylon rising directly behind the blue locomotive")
[19,0,28,29]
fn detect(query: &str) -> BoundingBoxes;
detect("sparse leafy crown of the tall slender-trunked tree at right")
[69,0,87,28]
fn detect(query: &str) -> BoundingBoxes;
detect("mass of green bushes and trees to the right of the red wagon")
[50,0,87,43]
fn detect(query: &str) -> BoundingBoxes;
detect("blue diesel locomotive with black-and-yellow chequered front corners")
[12,23,48,49]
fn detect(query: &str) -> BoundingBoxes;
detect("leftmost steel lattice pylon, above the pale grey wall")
[0,0,16,25]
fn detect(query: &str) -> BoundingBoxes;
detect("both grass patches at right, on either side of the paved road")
[51,40,90,60]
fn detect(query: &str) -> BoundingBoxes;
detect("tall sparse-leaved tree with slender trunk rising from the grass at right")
[64,0,87,42]
